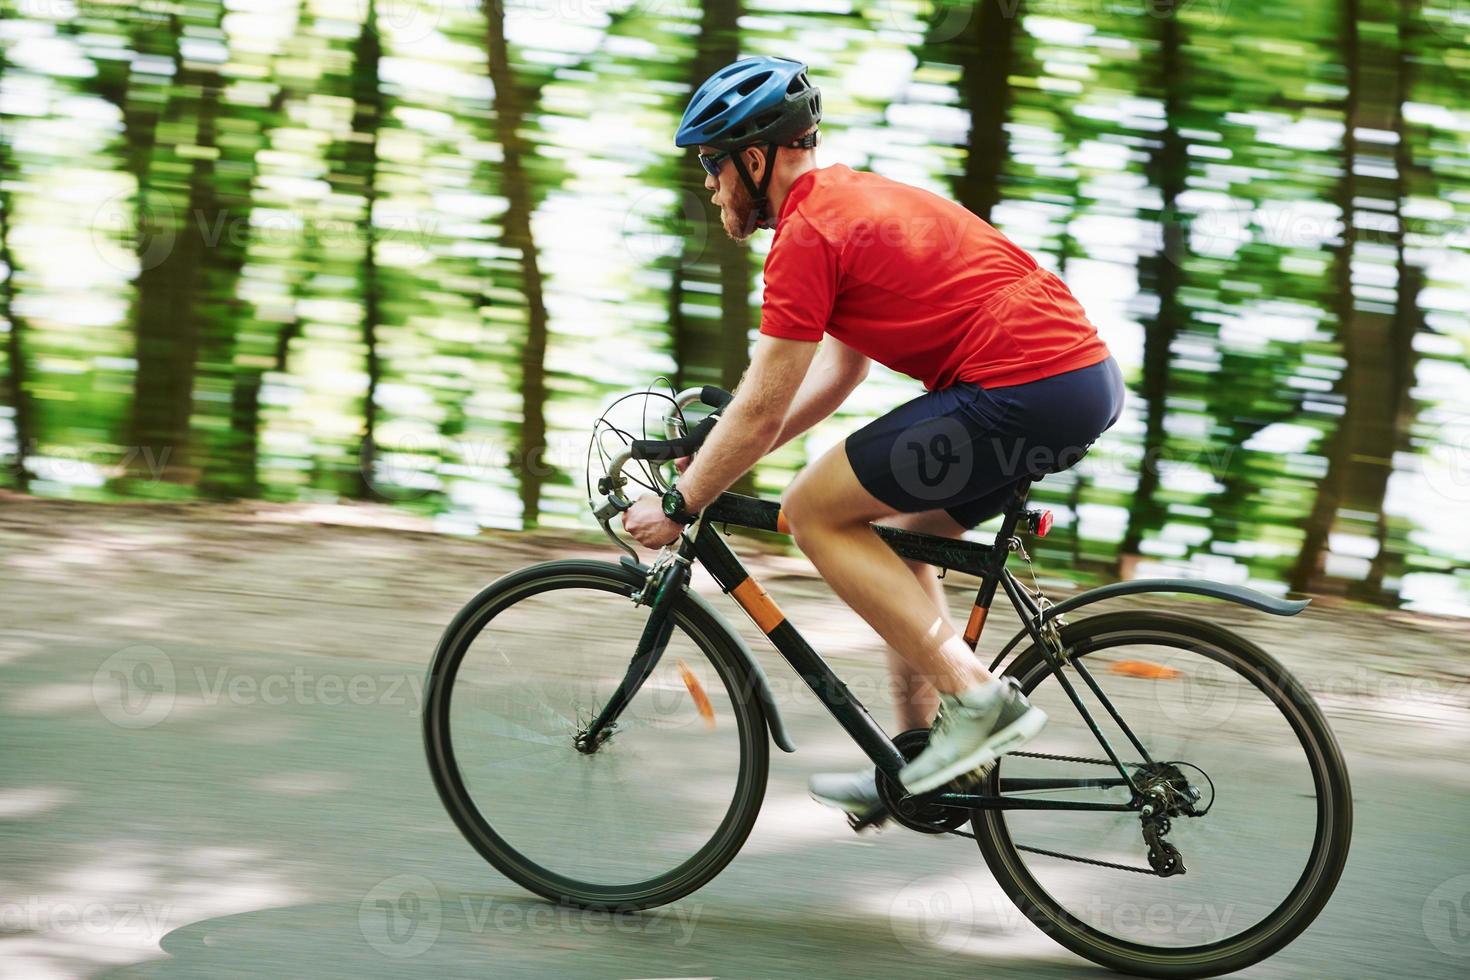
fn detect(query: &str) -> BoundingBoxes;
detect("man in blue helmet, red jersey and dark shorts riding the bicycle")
[623,57,1123,814]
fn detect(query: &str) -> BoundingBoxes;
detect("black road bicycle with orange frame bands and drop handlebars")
[423,386,1352,977]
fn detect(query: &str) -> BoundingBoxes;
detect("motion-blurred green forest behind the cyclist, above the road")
[0,0,1470,599]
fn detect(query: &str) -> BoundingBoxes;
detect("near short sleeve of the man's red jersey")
[760,212,839,341]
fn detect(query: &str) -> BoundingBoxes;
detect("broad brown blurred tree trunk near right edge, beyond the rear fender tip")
[1291,0,1419,601]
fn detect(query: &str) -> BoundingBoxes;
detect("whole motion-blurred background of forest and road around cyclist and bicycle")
[0,0,1470,980]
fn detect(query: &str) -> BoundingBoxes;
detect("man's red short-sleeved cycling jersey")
[760,165,1108,391]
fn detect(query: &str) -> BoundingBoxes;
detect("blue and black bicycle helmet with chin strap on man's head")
[673,57,822,228]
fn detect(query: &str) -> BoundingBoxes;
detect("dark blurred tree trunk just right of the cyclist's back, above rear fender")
[1119,13,1189,577]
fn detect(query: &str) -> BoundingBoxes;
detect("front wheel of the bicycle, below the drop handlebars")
[423,561,769,909]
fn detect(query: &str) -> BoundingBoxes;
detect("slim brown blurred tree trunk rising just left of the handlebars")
[482,0,551,527]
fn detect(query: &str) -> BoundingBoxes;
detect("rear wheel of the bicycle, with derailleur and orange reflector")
[972,611,1352,977]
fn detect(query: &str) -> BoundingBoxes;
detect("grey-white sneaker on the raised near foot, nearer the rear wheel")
[898,677,1047,795]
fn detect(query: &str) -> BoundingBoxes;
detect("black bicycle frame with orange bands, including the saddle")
[670,482,1151,811]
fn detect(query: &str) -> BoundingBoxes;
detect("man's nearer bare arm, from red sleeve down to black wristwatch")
[679,335,825,511]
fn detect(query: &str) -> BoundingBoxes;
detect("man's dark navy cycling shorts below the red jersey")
[847,357,1123,527]
